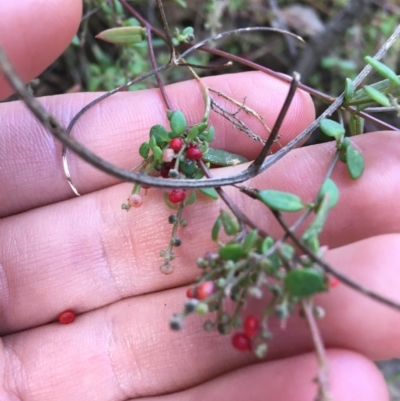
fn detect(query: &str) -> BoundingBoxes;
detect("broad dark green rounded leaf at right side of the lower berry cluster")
[284,267,326,297]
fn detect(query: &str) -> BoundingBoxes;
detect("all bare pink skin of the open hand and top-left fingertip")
[0,0,400,401]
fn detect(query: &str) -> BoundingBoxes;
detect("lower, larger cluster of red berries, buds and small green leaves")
[170,211,337,358]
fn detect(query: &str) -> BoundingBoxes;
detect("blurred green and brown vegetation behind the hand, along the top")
[26,0,400,139]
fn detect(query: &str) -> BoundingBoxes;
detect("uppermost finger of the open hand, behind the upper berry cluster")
[0,72,314,216]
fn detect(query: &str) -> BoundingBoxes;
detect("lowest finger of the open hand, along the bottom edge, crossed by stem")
[141,350,388,401]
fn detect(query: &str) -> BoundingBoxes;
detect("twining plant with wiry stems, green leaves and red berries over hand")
[2,0,400,399]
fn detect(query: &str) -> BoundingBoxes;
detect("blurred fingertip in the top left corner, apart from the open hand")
[0,0,82,99]
